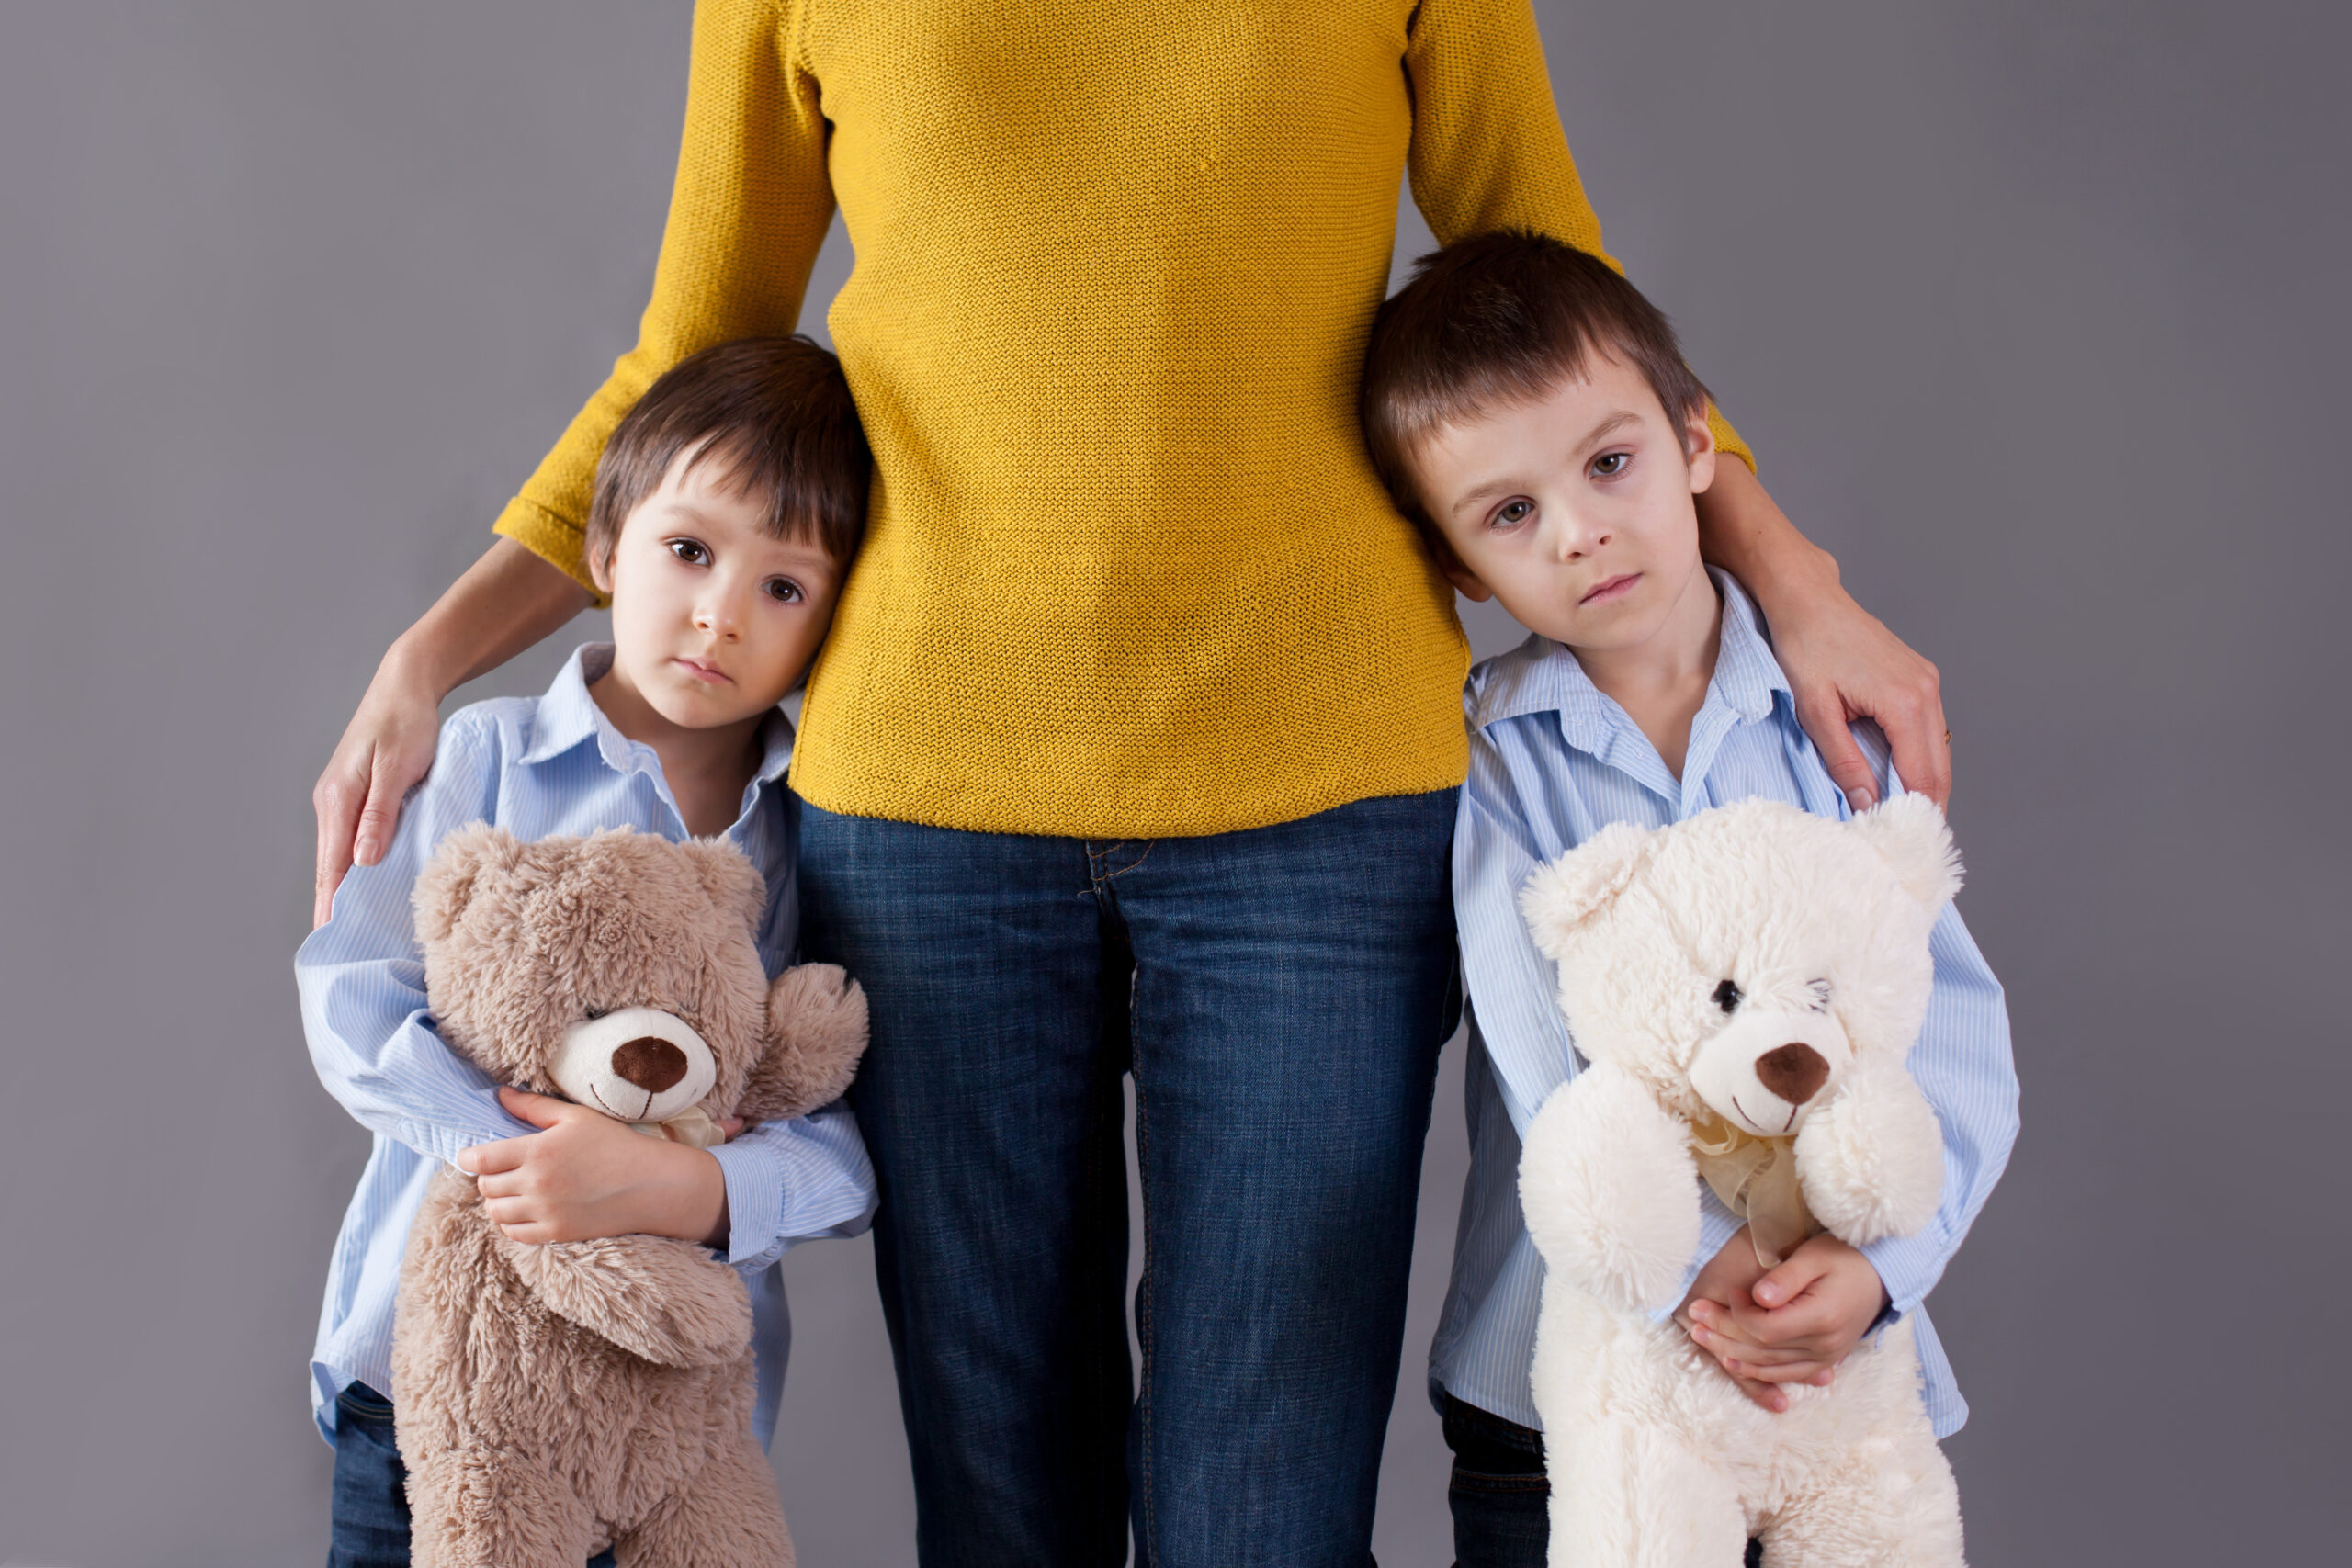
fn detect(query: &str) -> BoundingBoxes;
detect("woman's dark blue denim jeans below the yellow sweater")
[799,790,1458,1568]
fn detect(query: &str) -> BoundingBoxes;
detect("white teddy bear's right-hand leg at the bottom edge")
[1761,1422,1966,1568]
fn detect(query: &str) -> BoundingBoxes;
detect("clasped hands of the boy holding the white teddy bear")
[1679,1229,1886,1411]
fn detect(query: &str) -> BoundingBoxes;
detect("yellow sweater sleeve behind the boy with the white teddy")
[1404,0,1755,468]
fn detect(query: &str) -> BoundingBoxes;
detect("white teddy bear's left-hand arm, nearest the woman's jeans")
[1520,1063,1701,1312]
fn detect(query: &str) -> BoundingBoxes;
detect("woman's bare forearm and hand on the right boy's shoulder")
[1698,458,1952,811]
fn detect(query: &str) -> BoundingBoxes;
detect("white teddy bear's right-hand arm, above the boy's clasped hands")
[1797,1055,1943,1246]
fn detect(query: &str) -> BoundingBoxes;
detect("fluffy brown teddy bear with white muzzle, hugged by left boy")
[393,825,865,1568]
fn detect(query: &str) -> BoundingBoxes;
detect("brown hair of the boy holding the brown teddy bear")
[581,333,873,576]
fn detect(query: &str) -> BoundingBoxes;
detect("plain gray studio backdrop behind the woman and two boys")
[0,0,2352,1568]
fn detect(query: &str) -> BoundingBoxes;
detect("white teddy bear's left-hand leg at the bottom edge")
[1547,1422,1747,1568]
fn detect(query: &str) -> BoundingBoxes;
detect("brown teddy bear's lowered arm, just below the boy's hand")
[503,1236,751,1366]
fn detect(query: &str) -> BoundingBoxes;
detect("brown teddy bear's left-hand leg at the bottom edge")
[409,1448,595,1568]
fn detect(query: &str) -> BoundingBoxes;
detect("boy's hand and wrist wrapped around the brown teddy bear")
[457,1089,734,1246]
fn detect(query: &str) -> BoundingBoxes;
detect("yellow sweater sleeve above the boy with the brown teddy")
[496,0,832,602]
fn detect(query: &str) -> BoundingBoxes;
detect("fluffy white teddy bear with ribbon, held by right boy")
[1520,795,1962,1568]
